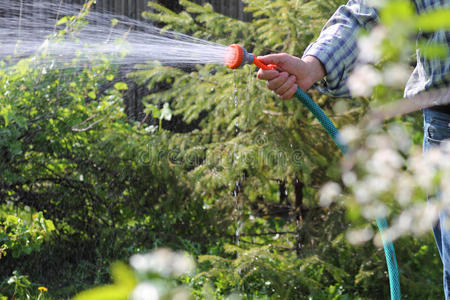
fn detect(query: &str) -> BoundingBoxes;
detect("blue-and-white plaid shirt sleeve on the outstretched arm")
[303,0,378,97]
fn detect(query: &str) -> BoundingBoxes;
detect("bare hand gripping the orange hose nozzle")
[258,53,326,100]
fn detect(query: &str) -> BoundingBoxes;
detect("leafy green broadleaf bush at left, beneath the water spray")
[0,2,220,297]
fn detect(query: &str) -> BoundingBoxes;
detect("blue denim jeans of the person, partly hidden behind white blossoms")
[423,109,450,300]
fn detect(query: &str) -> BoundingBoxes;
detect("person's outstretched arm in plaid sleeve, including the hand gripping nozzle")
[258,0,378,99]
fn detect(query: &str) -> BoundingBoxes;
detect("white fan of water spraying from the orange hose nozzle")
[0,0,227,68]
